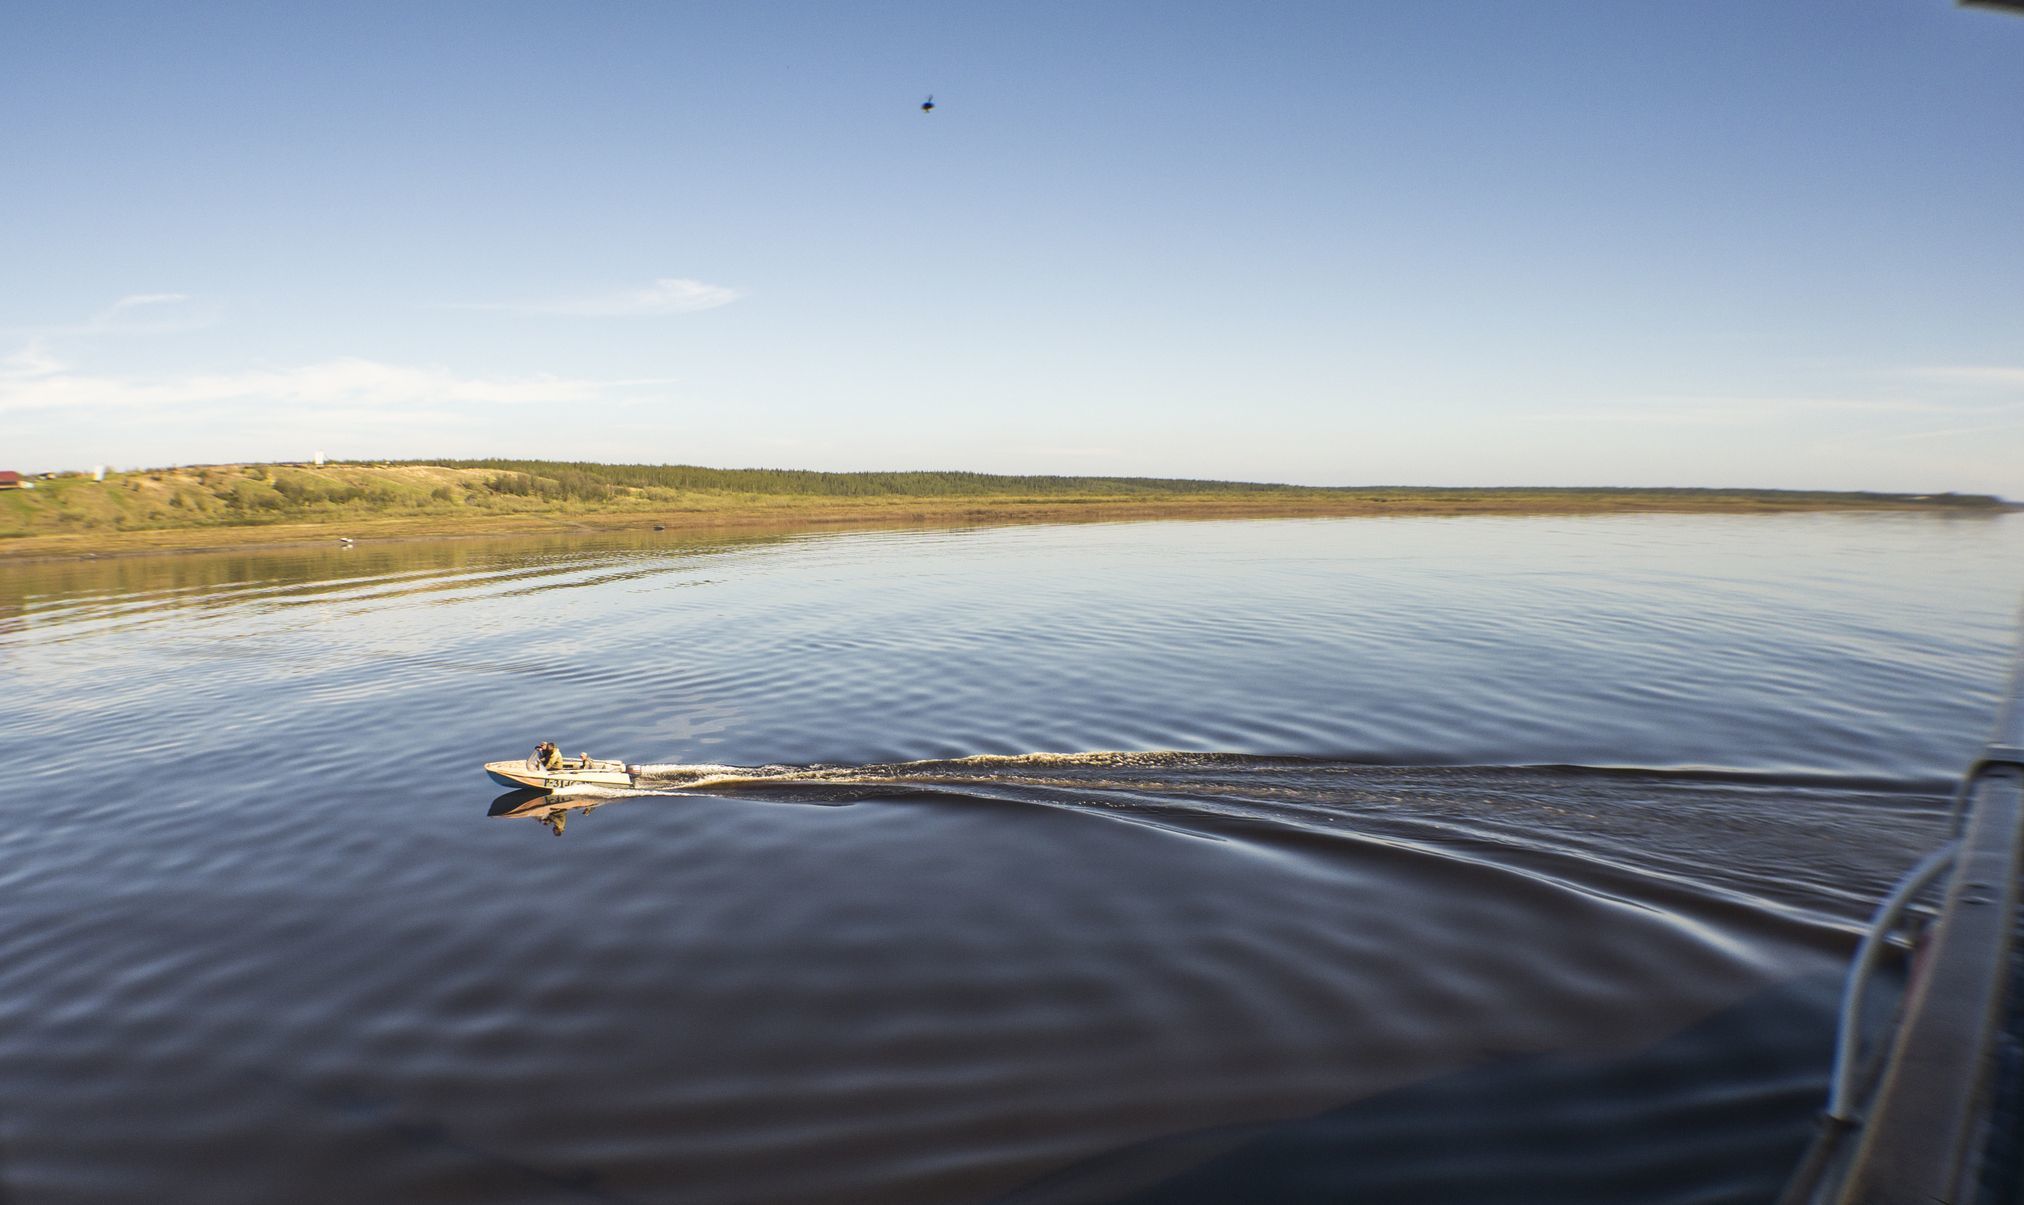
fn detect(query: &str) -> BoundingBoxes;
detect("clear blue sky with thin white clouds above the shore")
[0,0,2024,498]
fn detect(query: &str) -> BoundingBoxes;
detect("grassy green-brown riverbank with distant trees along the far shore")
[0,460,2006,557]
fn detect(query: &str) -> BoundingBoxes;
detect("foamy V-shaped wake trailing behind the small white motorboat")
[494,751,1945,932]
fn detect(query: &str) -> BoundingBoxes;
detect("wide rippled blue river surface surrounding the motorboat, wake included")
[0,516,2024,1205]
